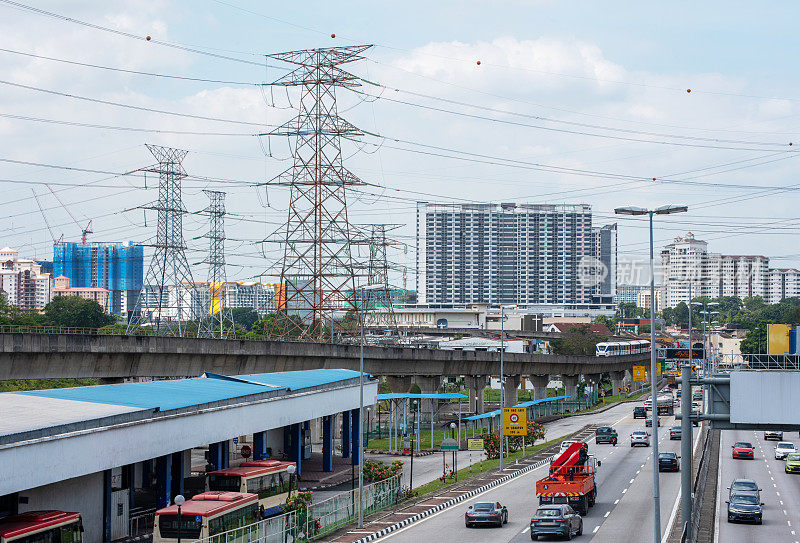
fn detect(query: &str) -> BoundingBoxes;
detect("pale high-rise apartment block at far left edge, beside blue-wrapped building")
[0,247,51,310]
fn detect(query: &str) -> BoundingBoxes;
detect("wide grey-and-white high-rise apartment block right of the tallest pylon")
[416,202,616,307]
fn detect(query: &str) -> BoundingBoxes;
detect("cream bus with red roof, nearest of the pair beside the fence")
[153,491,258,543]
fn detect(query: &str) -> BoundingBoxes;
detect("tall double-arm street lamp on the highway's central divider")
[614,205,691,543]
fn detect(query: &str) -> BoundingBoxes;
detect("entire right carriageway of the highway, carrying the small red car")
[714,430,800,543]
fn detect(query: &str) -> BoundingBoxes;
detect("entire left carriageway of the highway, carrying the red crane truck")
[384,398,700,543]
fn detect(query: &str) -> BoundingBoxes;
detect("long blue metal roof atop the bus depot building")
[13,369,358,411]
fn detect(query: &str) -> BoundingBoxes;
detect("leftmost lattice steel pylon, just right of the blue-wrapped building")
[127,144,205,337]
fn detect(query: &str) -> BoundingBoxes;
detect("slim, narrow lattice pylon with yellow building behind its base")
[200,190,236,338]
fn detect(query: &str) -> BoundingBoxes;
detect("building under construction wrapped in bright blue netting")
[53,242,144,316]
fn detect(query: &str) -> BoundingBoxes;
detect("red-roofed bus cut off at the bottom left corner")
[0,511,83,543]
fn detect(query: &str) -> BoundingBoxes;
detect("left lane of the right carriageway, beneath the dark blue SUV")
[714,430,795,543]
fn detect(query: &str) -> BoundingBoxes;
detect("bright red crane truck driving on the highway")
[536,441,600,515]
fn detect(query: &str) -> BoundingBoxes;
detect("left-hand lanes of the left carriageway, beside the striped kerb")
[382,409,647,543]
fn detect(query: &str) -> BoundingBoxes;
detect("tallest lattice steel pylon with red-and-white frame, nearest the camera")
[262,45,371,339]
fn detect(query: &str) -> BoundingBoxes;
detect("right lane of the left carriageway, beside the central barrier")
[591,417,684,542]
